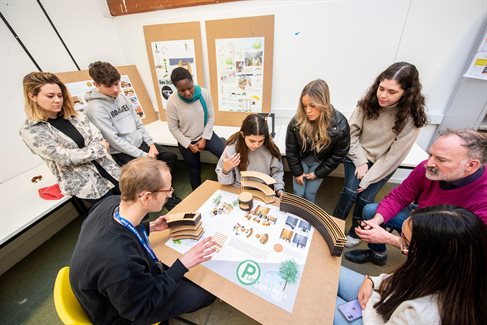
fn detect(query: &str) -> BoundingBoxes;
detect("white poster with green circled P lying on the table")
[166,190,314,312]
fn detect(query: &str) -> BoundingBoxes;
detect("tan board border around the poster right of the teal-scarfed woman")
[205,15,274,126]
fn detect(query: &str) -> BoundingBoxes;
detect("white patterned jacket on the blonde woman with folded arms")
[20,113,120,199]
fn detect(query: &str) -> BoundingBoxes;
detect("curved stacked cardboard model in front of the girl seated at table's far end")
[240,171,277,204]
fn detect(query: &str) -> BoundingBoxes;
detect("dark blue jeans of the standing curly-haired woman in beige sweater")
[333,158,394,238]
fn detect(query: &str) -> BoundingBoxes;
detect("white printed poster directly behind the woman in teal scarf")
[151,40,198,109]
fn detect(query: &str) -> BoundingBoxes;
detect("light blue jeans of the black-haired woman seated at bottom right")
[333,266,364,325]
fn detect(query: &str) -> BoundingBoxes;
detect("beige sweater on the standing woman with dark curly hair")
[348,107,420,189]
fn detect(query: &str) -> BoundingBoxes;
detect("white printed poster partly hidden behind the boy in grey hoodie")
[66,75,145,119]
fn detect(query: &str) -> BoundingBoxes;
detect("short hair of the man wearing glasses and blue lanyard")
[120,157,169,201]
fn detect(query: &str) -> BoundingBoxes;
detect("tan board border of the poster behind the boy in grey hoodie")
[56,65,157,124]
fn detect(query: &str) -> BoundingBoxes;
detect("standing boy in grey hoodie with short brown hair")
[85,61,181,210]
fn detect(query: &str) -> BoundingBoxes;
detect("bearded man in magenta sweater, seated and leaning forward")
[345,129,487,266]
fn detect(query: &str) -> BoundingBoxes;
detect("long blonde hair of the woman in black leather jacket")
[296,79,333,151]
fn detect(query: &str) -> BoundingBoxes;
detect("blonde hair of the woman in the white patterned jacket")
[23,72,77,121]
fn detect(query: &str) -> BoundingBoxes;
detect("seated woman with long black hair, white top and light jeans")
[333,205,487,325]
